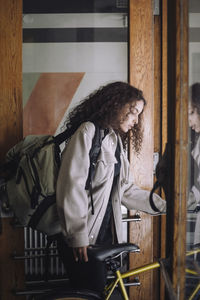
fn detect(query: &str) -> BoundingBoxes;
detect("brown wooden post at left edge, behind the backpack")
[0,0,24,300]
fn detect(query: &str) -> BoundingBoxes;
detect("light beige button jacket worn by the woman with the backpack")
[57,122,166,247]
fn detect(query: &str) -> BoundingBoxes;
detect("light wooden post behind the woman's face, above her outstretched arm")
[129,0,154,188]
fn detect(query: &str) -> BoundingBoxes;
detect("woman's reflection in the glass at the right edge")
[188,83,200,245]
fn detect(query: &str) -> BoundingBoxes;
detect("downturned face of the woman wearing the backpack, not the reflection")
[119,100,144,133]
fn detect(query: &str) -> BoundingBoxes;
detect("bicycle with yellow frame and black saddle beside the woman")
[34,243,200,300]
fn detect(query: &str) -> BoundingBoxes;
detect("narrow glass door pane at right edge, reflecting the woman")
[186,1,200,299]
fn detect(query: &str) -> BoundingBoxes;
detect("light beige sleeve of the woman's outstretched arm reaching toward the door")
[122,156,166,215]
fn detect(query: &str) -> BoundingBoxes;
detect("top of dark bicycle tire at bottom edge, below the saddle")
[38,290,103,300]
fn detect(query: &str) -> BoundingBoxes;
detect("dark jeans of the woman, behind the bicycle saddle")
[57,235,107,292]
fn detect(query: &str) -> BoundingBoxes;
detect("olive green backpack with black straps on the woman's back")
[0,125,101,235]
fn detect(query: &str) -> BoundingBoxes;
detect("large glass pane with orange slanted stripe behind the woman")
[23,0,128,280]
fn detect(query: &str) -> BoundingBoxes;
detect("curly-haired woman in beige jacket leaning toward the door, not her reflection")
[57,82,165,290]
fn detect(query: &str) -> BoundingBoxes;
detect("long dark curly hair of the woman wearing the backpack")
[65,81,146,153]
